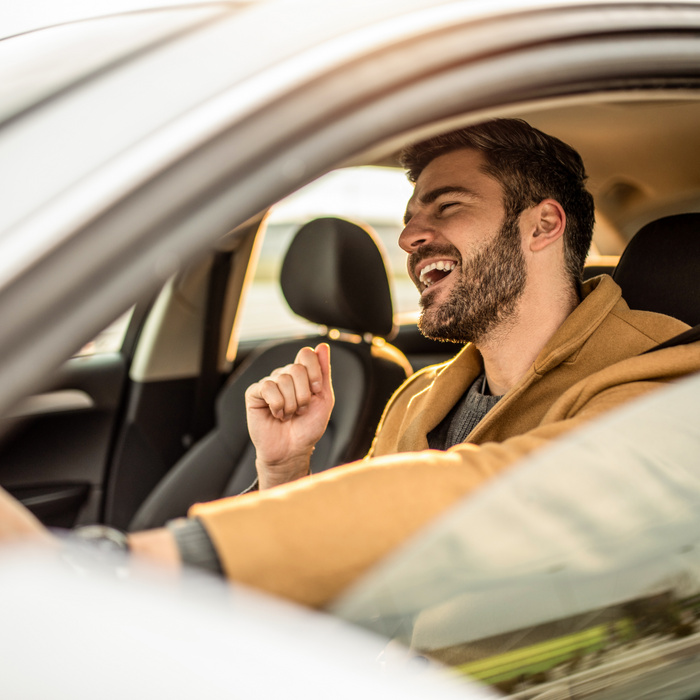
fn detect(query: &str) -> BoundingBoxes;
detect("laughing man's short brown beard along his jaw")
[412,217,527,345]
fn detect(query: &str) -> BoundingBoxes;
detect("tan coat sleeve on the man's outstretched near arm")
[190,348,698,607]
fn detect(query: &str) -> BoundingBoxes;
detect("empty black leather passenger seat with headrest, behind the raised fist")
[129,218,411,530]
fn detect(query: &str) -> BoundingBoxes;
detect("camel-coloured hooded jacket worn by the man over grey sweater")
[189,276,700,606]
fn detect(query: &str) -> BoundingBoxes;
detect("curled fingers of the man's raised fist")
[246,343,330,420]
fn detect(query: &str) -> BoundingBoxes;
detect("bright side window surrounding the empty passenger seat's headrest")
[235,167,418,340]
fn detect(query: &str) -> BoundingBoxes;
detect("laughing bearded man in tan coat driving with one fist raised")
[0,120,700,605]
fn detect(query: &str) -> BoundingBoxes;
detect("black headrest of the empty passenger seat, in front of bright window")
[281,217,394,337]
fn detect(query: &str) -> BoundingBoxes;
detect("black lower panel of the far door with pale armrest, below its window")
[0,353,127,527]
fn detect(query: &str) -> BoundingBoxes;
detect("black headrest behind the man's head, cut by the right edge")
[613,214,700,326]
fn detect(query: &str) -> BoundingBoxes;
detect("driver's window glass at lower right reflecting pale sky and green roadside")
[334,375,700,700]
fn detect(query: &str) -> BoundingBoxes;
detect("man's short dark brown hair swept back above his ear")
[400,119,594,285]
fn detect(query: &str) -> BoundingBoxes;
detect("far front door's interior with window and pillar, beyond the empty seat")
[0,221,264,528]
